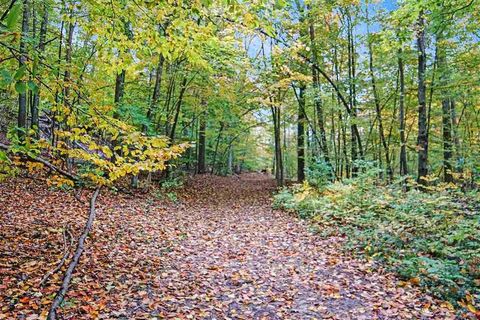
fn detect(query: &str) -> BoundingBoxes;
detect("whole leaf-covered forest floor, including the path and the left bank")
[0,174,454,319]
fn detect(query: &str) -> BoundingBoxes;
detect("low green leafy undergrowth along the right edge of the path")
[275,178,480,310]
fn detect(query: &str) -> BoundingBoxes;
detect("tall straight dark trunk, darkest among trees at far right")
[417,11,428,185]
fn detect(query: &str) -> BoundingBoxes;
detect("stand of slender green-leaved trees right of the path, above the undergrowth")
[262,0,480,185]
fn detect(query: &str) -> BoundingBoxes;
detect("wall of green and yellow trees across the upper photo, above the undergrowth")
[1,0,479,185]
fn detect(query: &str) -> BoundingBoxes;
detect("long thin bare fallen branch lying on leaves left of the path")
[47,187,100,320]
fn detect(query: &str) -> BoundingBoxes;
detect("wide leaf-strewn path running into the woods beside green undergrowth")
[152,174,452,319]
